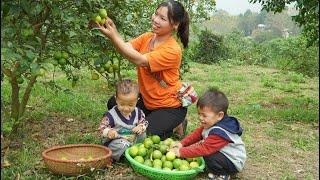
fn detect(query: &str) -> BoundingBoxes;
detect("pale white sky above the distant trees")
[216,0,261,15]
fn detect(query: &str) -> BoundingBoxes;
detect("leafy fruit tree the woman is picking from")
[1,0,214,135]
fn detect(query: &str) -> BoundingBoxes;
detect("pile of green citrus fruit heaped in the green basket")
[128,135,201,171]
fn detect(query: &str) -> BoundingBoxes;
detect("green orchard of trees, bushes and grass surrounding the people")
[1,0,319,179]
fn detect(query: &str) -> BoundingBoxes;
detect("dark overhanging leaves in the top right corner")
[249,0,319,46]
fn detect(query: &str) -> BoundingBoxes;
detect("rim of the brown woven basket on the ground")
[42,144,112,163]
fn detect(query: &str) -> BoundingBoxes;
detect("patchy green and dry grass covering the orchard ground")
[1,63,319,180]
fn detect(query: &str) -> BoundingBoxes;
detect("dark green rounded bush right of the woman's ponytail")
[192,29,228,64]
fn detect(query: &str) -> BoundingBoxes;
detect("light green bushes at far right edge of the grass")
[224,31,319,76]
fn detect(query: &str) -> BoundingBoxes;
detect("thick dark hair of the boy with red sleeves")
[197,87,229,114]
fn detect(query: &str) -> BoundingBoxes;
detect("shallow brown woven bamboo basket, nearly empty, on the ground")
[42,144,112,176]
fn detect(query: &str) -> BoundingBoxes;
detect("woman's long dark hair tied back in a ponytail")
[157,0,189,48]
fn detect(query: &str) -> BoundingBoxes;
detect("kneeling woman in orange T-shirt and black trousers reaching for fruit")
[96,0,189,139]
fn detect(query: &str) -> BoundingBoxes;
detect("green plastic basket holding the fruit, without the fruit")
[125,148,205,180]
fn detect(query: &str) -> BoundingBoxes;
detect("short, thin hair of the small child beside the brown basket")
[116,79,139,96]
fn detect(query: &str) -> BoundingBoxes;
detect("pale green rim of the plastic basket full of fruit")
[125,143,205,175]
